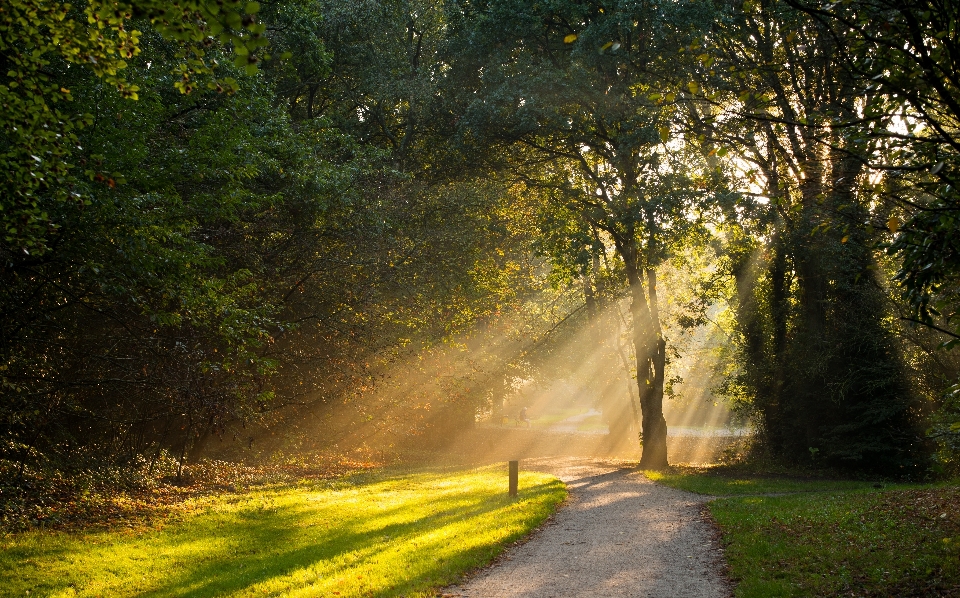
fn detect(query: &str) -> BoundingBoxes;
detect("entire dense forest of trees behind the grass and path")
[0,0,960,508]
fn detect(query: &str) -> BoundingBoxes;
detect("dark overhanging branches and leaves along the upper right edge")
[789,0,960,346]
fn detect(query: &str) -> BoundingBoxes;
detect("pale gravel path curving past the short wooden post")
[443,458,730,598]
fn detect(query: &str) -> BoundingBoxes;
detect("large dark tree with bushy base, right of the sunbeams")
[693,3,924,473]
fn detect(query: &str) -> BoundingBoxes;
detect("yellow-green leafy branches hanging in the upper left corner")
[0,0,265,254]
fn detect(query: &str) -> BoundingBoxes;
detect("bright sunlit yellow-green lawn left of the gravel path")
[0,467,566,598]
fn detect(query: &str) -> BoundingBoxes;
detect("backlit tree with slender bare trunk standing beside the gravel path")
[442,1,709,468]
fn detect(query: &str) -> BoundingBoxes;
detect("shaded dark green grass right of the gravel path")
[647,468,960,598]
